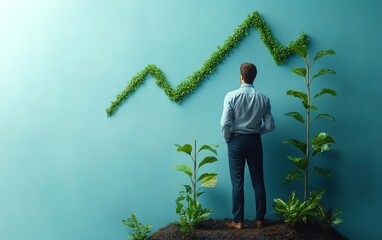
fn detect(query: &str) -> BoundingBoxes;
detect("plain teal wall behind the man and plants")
[0,0,382,240]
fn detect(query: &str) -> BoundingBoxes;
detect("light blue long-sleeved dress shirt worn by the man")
[220,84,275,143]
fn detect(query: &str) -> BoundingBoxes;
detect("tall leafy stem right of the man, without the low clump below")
[284,45,337,201]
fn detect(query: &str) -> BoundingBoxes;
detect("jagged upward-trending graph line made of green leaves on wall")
[106,11,309,117]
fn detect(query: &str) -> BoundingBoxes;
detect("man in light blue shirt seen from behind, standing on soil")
[220,63,275,230]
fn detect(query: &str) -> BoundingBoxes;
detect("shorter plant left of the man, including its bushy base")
[174,140,218,232]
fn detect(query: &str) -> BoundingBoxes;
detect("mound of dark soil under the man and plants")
[149,219,347,240]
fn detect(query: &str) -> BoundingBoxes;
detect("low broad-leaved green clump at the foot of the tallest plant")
[273,190,325,226]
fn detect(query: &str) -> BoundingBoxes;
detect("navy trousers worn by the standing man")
[228,134,266,223]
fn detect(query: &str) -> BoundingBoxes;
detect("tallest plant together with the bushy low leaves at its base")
[273,46,342,229]
